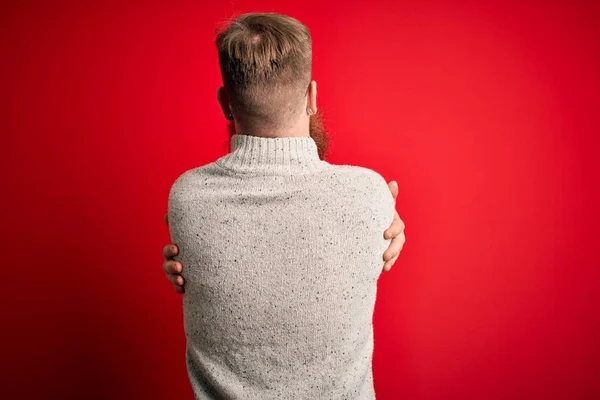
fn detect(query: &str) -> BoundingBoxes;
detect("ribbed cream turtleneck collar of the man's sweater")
[216,134,329,175]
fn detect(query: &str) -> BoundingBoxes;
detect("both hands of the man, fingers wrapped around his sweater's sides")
[163,181,406,293]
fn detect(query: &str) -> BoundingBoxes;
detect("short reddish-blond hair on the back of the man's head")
[216,12,312,128]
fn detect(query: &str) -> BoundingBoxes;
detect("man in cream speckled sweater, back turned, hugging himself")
[164,13,405,400]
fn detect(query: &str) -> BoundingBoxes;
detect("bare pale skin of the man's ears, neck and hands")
[163,81,406,293]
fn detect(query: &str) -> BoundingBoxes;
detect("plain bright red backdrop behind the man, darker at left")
[0,0,600,400]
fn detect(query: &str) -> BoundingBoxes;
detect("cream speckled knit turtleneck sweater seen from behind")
[168,134,394,400]
